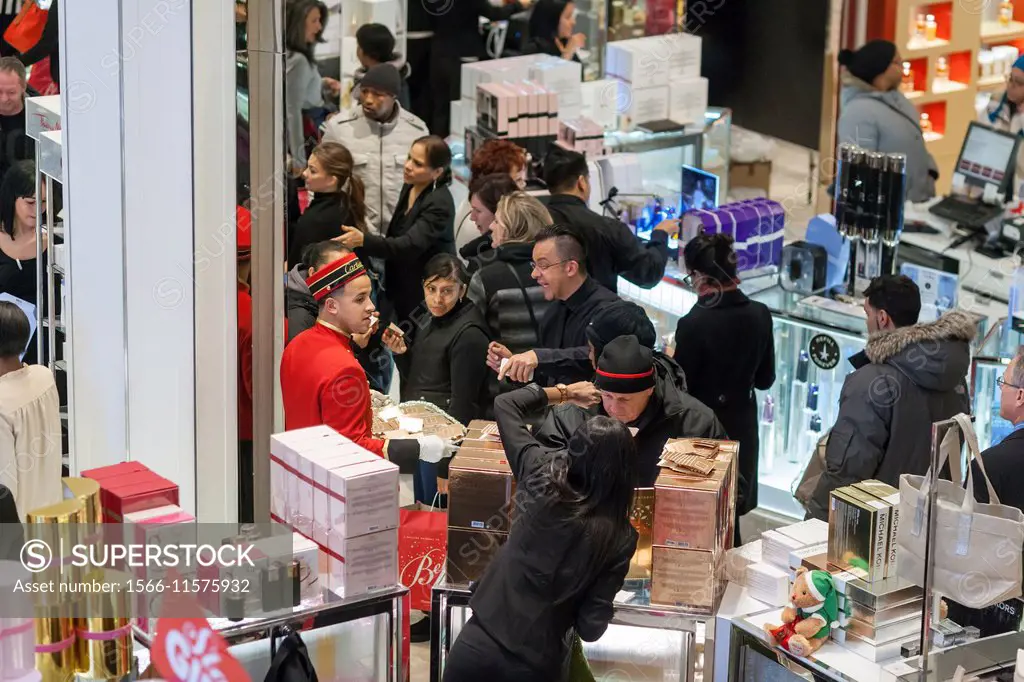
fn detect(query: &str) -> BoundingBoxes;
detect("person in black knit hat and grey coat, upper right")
[838,40,939,203]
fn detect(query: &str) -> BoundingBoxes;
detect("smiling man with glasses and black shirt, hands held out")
[487,225,620,386]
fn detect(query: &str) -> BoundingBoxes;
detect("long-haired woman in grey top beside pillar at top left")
[285,0,341,176]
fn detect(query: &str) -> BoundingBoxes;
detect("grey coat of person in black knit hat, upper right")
[838,74,938,203]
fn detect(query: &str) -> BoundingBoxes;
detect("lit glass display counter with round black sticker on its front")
[618,264,866,518]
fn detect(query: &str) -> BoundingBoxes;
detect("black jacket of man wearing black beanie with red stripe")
[537,353,727,487]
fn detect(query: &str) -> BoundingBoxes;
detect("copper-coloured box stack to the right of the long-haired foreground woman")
[650,439,739,613]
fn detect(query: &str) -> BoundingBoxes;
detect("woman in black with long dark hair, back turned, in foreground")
[443,384,637,682]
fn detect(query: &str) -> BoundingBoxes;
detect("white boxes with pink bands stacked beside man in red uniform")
[270,426,398,597]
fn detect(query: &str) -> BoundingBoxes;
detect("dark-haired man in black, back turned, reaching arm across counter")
[544,147,678,292]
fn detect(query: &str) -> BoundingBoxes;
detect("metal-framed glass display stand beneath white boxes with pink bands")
[135,585,409,682]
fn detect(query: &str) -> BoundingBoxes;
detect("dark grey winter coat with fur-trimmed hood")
[808,310,977,520]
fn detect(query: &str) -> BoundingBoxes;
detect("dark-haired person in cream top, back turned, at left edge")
[0,301,62,519]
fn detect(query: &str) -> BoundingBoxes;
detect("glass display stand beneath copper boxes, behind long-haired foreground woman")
[430,574,730,682]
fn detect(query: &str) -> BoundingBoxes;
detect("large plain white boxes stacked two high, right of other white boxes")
[604,33,708,131]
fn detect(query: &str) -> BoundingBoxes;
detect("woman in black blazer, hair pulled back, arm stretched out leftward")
[338,135,455,341]
